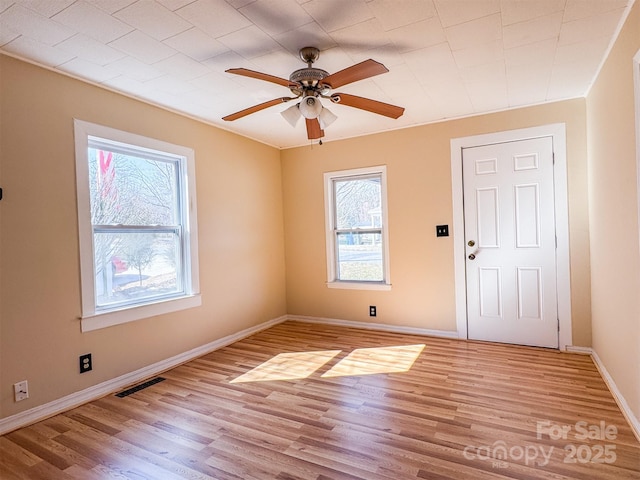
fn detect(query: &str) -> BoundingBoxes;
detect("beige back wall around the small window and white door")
[282,99,591,346]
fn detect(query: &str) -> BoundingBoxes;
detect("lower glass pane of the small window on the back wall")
[336,232,384,282]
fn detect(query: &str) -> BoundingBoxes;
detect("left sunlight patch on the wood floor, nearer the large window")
[230,350,342,383]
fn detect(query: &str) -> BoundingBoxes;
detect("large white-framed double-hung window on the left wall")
[75,120,200,331]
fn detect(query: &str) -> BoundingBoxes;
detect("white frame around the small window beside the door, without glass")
[324,165,391,290]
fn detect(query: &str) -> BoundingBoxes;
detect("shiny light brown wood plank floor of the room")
[0,321,640,480]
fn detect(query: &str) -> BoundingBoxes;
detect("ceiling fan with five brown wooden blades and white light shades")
[222,47,404,140]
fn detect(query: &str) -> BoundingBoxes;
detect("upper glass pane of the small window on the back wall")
[334,176,382,230]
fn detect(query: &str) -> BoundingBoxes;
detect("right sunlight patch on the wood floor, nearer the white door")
[322,344,425,377]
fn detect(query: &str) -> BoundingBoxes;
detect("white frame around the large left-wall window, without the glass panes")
[74,119,201,332]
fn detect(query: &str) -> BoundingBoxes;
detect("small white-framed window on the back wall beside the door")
[324,166,391,289]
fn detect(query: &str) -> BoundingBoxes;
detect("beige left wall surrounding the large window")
[0,56,286,418]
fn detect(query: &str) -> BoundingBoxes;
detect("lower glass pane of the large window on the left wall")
[94,232,184,307]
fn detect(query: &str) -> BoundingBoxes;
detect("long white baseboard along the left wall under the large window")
[0,315,288,435]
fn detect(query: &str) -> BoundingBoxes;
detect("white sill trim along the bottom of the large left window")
[80,294,202,333]
